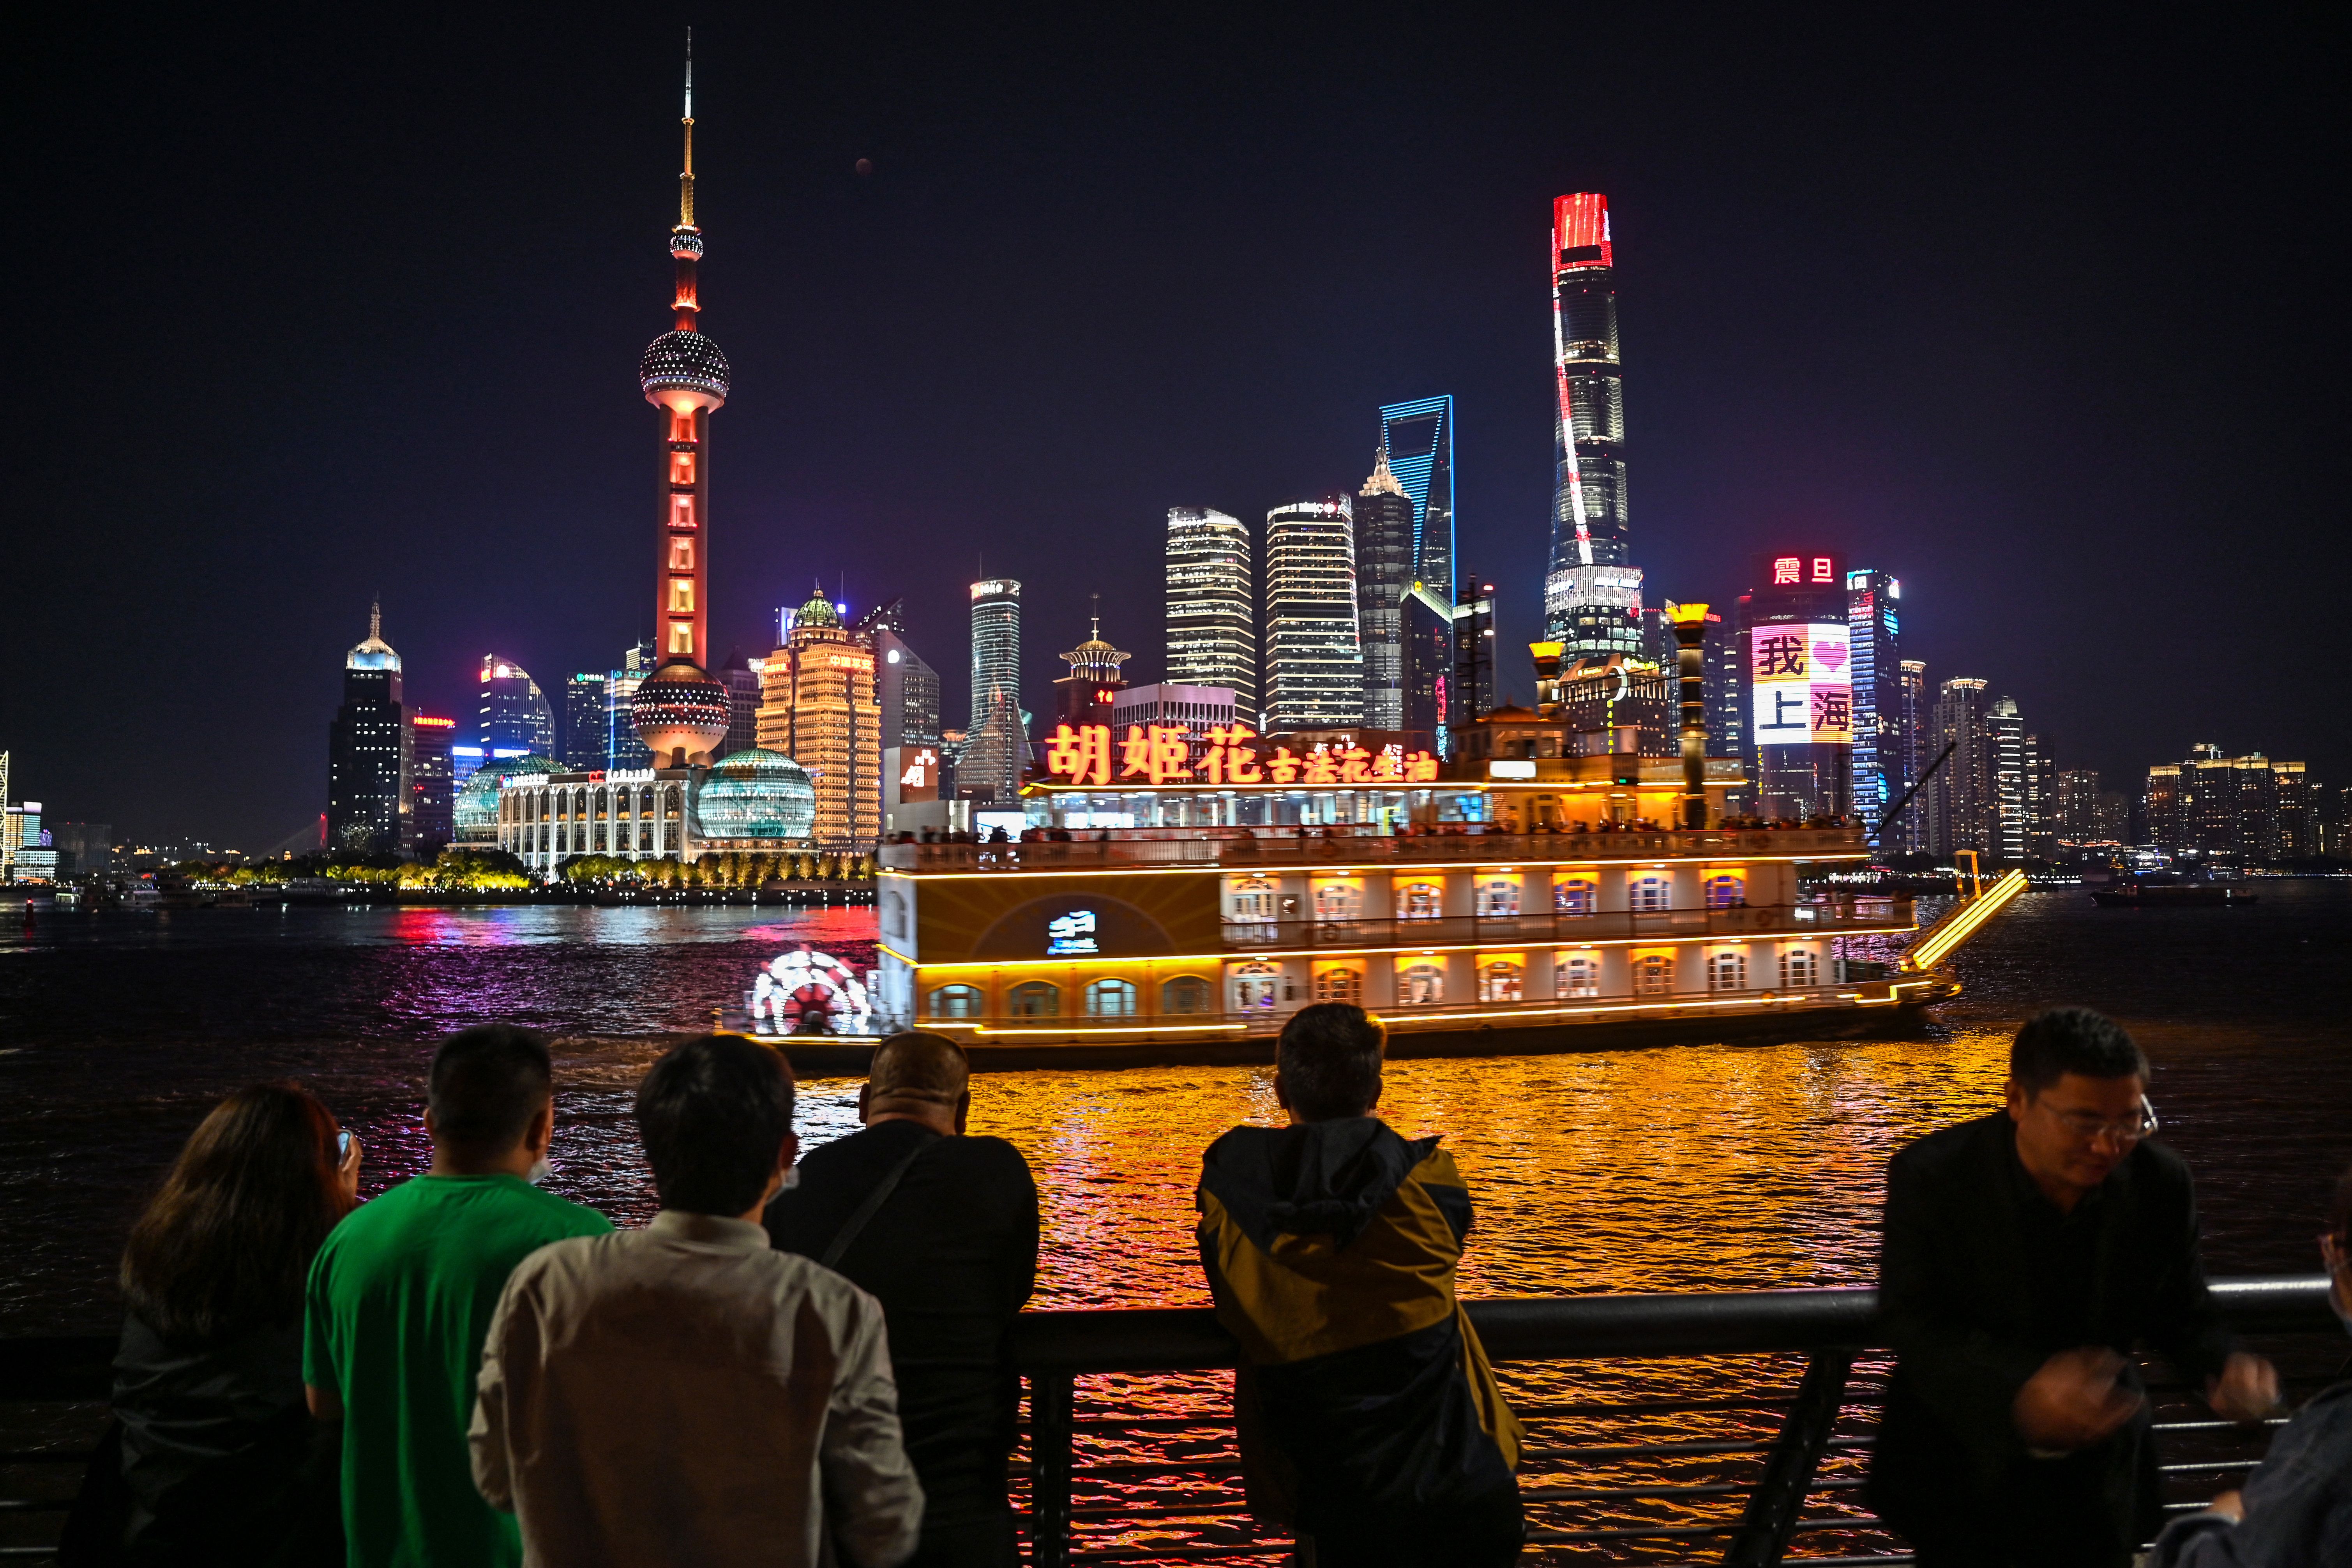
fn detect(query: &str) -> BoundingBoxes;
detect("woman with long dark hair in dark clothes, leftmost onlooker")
[73,1084,360,1568]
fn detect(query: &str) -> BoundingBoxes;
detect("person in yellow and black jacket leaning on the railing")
[1197,1001,1526,1568]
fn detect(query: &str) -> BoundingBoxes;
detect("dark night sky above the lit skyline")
[0,5,2352,849]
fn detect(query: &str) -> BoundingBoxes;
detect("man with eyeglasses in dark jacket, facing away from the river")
[1870,1008,2279,1568]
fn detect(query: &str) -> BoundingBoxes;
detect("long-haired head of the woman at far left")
[122,1084,346,1345]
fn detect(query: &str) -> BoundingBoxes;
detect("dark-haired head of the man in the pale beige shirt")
[637,1035,793,1218]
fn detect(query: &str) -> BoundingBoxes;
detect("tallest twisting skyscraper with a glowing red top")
[1543,193,1642,663]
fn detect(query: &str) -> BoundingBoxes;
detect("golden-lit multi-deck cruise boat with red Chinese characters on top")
[865,726,1985,1065]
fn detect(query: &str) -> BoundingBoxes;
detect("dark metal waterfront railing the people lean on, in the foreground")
[0,1274,2343,1568]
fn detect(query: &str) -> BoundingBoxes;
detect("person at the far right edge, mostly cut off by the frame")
[2147,1171,2352,1568]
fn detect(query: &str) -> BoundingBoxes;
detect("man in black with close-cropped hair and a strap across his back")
[767,1032,1037,1568]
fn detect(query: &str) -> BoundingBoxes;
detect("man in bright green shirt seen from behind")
[304,1022,611,1568]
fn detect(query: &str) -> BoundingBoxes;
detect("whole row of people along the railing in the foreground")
[59,1001,2352,1568]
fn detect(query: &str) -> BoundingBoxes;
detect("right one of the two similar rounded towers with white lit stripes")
[1270,496,1364,736]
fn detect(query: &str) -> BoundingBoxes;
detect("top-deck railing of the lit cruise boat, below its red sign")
[877,825,1870,874]
